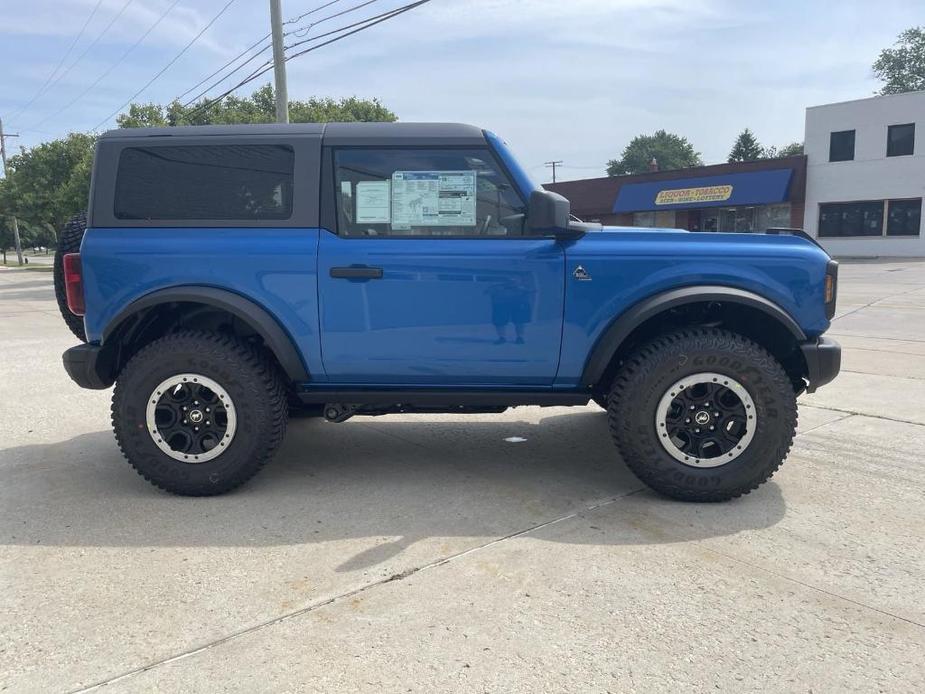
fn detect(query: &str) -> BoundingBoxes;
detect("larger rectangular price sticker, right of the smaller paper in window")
[392,171,476,229]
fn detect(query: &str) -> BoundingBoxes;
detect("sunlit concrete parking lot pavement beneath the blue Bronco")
[0,261,925,692]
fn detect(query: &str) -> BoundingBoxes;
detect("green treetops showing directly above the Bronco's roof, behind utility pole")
[116,84,398,128]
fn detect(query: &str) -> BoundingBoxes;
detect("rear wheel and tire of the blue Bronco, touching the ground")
[112,331,287,496]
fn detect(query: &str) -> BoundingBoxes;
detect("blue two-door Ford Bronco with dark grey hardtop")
[57,123,841,501]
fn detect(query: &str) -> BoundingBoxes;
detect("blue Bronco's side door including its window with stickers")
[318,147,565,386]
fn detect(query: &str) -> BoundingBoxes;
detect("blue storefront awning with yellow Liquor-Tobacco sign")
[613,169,793,212]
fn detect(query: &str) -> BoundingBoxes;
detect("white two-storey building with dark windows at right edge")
[804,91,925,257]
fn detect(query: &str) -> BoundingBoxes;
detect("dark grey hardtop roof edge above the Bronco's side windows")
[102,123,484,144]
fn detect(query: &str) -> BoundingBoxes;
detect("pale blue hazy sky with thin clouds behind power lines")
[0,0,925,182]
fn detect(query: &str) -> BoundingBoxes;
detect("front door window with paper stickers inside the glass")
[334,148,527,236]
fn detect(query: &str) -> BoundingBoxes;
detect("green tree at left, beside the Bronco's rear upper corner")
[0,133,96,232]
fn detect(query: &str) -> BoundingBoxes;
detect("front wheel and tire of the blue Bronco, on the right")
[608,329,797,501]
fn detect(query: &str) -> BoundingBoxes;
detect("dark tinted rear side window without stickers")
[113,145,295,221]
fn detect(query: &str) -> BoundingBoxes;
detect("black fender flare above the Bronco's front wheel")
[581,285,807,388]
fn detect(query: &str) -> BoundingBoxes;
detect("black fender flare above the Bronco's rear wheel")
[100,285,309,382]
